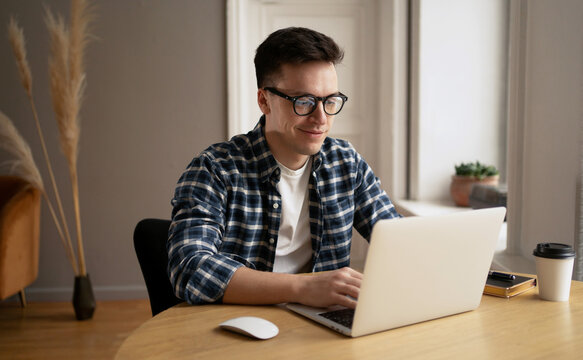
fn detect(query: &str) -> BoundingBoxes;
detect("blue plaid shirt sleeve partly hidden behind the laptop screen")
[354,153,401,240]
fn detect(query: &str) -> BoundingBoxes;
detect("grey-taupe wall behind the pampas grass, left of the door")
[0,0,227,301]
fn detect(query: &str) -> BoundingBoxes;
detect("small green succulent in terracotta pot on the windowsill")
[450,161,500,206]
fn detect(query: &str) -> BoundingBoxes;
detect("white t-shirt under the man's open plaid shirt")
[273,158,312,274]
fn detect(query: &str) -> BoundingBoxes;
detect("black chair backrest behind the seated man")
[134,219,183,316]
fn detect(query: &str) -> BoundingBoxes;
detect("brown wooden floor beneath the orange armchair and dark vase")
[0,300,152,359]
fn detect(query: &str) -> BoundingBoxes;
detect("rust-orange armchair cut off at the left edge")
[0,176,41,306]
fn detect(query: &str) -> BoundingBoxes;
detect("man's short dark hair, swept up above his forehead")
[255,27,344,88]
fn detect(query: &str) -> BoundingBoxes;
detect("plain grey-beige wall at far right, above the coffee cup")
[509,0,583,270]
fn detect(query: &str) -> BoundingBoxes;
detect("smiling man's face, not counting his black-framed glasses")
[257,61,338,169]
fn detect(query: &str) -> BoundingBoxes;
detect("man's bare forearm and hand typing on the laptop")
[223,267,362,308]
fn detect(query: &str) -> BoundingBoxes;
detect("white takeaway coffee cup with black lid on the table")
[533,243,575,301]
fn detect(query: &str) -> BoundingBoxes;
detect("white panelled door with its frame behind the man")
[227,0,406,267]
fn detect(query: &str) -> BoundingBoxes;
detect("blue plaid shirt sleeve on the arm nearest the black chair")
[167,155,244,304]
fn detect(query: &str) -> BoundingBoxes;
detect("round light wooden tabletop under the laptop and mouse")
[116,281,583,360]
